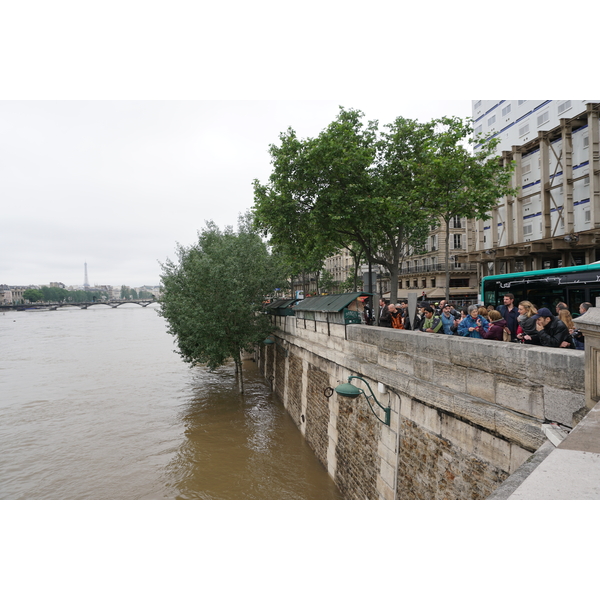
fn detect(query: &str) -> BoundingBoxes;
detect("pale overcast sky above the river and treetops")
[0,98,470,286]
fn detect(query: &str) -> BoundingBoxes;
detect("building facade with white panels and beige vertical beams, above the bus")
[462,100,600,278]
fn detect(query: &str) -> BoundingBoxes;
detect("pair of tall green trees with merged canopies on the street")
[253,108,511,301]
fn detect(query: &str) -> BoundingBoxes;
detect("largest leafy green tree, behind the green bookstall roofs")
[254,108,431,301]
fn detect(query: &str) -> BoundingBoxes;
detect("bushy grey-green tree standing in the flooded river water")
[160,215,283,392]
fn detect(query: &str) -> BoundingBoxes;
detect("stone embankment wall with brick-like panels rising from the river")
[259,317,585,499]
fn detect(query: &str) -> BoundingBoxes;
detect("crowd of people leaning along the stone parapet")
[364,293,591,350]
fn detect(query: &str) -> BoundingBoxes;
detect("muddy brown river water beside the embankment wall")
[0,305,340,500]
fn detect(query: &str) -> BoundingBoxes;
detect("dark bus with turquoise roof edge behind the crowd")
[481,261,600,314]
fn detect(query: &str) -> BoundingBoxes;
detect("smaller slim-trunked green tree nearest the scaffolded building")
[419,117,515,301]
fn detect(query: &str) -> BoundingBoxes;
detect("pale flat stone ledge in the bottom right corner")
[488,402,600,500]
